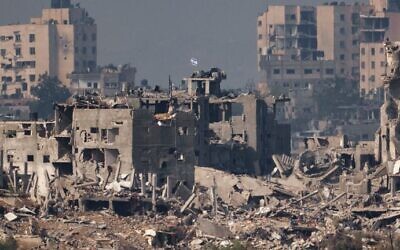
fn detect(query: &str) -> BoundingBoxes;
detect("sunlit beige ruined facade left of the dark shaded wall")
[72,109,132,184]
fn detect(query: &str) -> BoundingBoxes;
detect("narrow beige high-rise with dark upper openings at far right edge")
[360,0,400,98]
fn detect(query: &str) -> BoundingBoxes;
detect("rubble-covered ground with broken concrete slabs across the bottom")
[0,164,400,249]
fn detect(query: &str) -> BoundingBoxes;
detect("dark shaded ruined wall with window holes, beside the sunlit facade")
[132,109,198,185]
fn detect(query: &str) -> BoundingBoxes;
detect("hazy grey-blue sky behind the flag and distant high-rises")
[0,0,368,88]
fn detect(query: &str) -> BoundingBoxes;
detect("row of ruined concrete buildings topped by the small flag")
[0,68,290,213]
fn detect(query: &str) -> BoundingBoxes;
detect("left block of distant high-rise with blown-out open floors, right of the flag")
[257,6,335,94]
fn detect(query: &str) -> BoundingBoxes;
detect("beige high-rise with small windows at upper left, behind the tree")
[0,1,97,96]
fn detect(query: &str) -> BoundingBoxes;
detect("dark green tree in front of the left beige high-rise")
[29,75,71,119]
